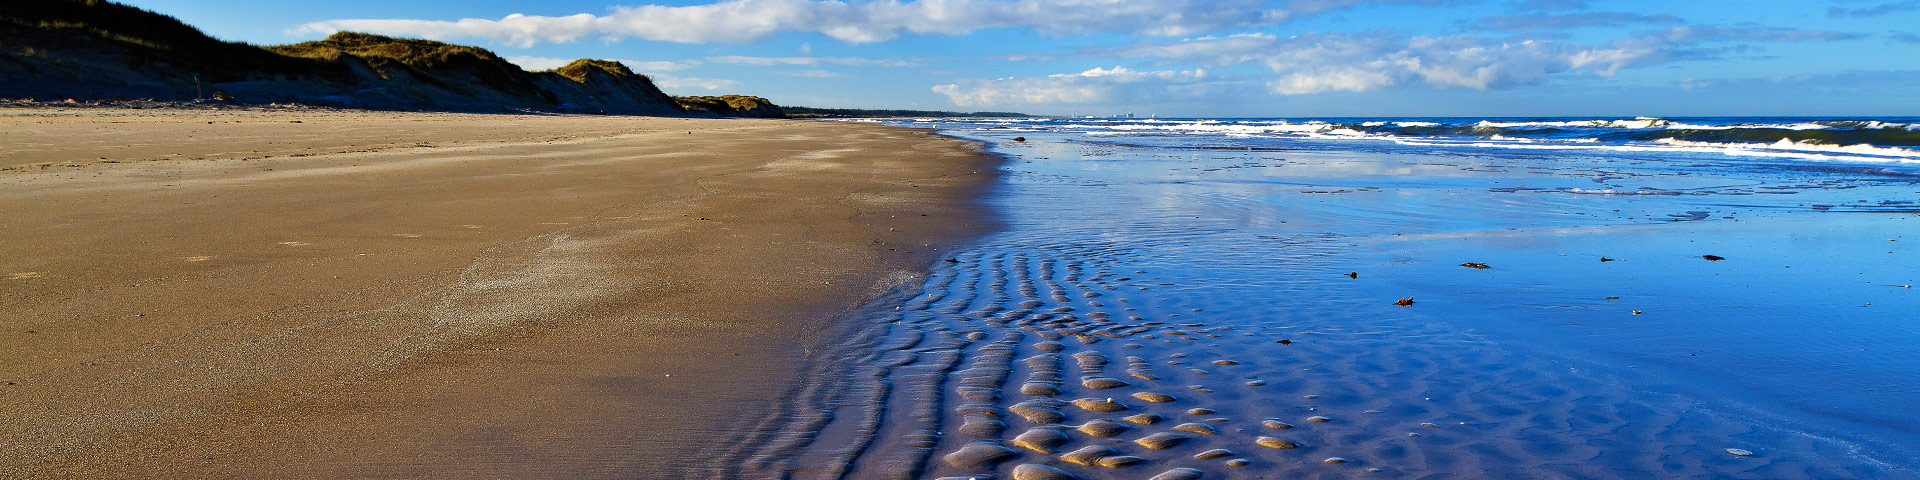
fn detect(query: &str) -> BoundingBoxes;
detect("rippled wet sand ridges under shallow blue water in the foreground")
[721,240,1878,478]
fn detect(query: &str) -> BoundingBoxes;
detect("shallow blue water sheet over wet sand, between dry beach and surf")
[721,121,1920,478]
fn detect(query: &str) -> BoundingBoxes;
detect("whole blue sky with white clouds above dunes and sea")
[116,0,1920,117]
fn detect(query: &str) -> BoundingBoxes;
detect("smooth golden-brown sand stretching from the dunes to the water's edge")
[0,108,996,478]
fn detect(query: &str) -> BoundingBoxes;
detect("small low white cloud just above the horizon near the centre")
[933,67,1221,108]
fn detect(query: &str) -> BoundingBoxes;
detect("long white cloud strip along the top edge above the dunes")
[288,0,1417,48]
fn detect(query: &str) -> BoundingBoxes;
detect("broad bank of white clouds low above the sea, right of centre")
[933,17,1860,108]
